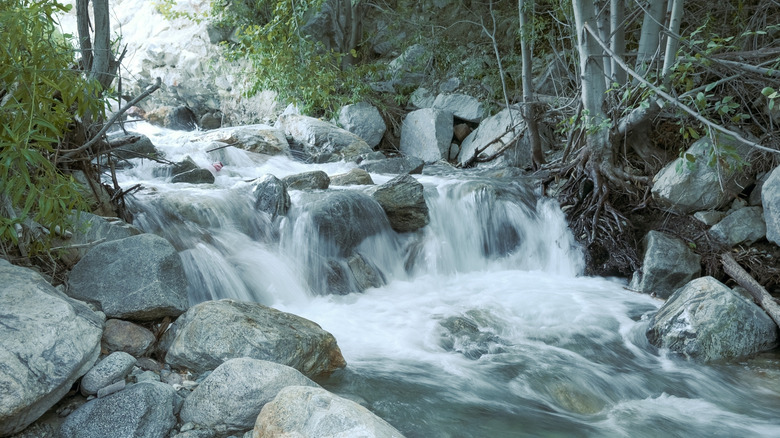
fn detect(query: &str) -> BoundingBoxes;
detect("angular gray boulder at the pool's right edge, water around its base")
[647,277,778,362]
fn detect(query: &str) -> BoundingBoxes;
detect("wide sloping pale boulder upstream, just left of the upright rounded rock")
[275,114,372,162]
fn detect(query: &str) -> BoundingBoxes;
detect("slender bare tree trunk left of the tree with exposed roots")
[517,0,545,169]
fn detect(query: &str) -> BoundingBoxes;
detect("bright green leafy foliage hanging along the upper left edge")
[0,0,105,247]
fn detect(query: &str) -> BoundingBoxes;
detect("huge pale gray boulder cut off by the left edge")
[0,259,103,436]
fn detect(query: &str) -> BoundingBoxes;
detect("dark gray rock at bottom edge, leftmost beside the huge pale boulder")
[59,382,177,438]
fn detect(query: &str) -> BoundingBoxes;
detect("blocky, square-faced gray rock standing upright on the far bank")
[400,108,452,163]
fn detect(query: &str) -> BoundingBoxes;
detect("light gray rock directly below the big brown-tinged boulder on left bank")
[180,358,318,431]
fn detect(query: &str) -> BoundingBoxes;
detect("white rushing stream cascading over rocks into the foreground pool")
[111,124,780,437]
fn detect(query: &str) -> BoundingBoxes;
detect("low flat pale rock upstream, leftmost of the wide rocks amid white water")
[193,125,290,155]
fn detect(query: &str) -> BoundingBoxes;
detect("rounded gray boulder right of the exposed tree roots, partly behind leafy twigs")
[652,135,753,214]
